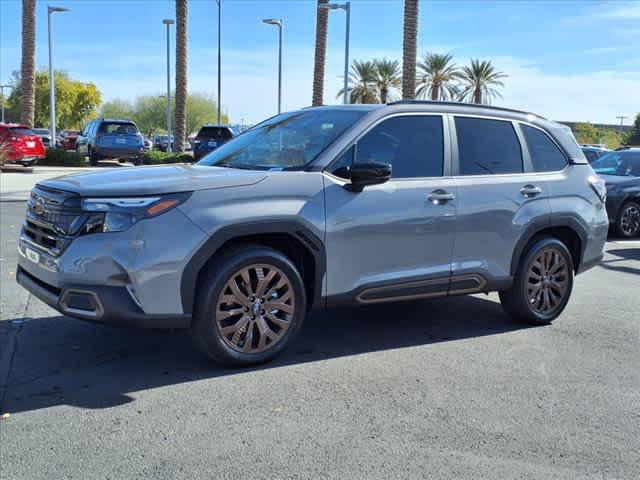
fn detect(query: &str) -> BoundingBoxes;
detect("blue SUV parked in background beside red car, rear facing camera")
[76,118,144,165]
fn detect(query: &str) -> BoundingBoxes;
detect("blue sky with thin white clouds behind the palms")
[0,0,640,124]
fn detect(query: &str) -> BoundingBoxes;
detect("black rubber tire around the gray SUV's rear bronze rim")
[500,236,575,325]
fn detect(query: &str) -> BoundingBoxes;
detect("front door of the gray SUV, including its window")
[324,114,457,303]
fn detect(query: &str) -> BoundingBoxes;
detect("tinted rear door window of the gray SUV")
[456,117,523,175]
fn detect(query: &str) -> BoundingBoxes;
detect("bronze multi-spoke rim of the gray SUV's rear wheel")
[526,247,570,316]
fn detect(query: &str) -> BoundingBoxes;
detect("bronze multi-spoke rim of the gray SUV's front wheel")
[215,264,295,353]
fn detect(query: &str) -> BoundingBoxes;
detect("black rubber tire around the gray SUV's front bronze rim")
[191,245,306,366]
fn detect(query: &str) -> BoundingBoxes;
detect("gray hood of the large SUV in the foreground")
[38,164,267,197]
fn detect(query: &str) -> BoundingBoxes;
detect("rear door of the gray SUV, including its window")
[450,115,550,284]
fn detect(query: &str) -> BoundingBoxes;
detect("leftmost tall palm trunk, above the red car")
[20,0,36,127]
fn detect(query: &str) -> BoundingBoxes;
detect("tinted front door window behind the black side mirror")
[356,115,444,178]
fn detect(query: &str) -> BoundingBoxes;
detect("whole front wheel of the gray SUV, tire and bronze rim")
[192,245,306,366]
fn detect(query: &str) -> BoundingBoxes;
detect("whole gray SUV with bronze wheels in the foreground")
[17,102,609,365]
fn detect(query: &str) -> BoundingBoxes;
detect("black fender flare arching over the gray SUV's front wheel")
[180,218,327,314]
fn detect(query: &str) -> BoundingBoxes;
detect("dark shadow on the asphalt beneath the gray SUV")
[0,296,523,413]
